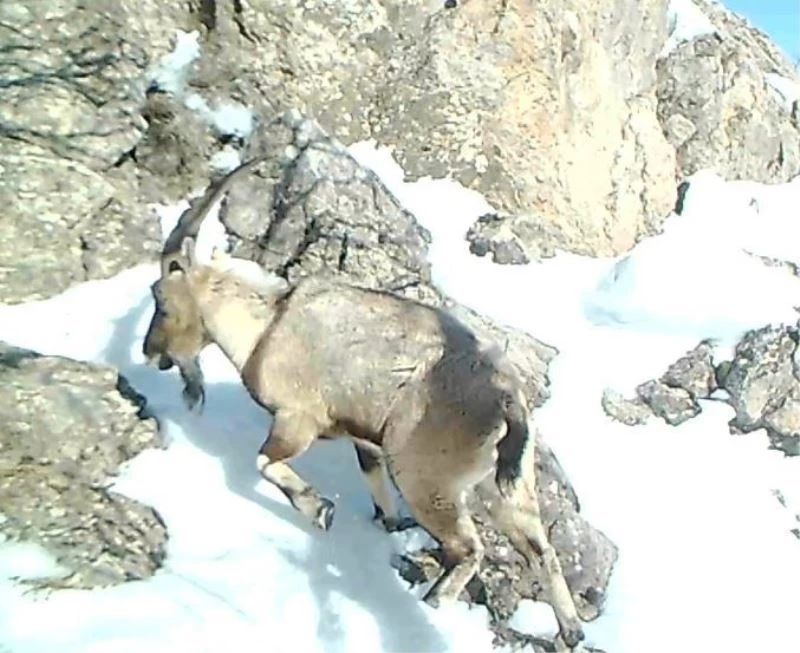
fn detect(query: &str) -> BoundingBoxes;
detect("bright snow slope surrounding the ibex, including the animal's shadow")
[0,143,800,653]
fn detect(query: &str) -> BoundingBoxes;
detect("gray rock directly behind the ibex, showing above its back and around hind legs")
[217,112,617,636]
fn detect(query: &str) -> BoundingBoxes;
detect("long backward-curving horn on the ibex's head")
[161,155,266,277]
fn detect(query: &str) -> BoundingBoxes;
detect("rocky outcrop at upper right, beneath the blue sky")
[657,0,800,182]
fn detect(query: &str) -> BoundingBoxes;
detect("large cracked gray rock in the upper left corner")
[0,0,173,303]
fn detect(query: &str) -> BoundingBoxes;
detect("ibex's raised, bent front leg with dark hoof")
[257,410,334,531]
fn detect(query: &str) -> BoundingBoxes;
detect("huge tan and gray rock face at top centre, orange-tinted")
[180,0,675,259]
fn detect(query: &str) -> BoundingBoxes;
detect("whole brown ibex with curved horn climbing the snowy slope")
[143,154,584,648]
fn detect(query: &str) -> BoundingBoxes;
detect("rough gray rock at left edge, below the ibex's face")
[0,343,167,588]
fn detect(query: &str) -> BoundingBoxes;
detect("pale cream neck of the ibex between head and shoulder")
[196,270,282,372]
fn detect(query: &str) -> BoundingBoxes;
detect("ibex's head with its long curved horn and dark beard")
[142,158,268,410]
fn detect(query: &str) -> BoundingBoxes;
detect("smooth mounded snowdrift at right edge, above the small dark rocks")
[584,170,800,341]
